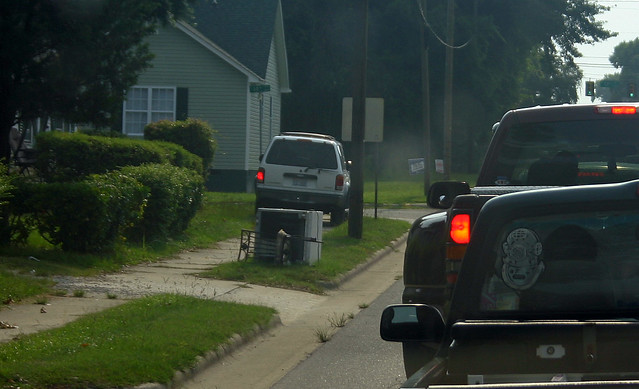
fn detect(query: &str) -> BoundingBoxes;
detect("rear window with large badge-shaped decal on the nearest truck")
[479,211,639,313]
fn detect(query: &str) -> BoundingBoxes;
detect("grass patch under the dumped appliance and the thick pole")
[200,217,410,294]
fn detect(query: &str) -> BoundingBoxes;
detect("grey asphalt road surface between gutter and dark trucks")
[272,280,406,389]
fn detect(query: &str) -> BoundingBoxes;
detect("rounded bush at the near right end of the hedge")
[117,164,204,241]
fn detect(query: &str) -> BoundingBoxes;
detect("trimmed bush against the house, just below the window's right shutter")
[144,119,217,174]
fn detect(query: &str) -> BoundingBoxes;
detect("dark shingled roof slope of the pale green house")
[193,0,281,78]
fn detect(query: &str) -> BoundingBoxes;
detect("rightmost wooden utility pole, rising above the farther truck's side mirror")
[444,0,455,180]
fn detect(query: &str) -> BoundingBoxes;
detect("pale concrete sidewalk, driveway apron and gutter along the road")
[0,230,406,388]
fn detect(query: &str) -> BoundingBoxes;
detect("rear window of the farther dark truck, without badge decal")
[488,119,639,186]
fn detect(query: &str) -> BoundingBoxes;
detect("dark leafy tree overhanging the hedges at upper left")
[0,0,194,163]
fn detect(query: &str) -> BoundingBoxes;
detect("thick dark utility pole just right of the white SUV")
[348,0,368,239]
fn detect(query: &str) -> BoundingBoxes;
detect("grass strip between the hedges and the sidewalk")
[0,192,255,309]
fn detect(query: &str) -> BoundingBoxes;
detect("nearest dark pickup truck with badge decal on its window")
[380,180,639,388]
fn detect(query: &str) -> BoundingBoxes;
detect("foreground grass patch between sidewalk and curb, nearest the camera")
[0,294,275,388]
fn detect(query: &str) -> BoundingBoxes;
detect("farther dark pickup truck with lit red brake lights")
[402,103,639,375]
